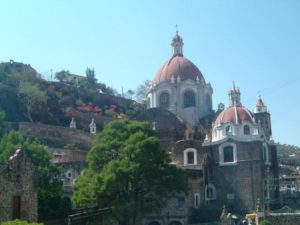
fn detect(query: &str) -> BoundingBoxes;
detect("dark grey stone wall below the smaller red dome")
[206,140,278,213]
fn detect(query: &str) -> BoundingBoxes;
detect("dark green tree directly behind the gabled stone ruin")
[0,131,63,214]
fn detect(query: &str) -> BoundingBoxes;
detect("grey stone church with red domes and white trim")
[137,32,279,225]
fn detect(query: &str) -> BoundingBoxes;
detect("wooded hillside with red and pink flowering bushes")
[0,61,143,131]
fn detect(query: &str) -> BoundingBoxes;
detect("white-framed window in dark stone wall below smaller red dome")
[219,143,237,166]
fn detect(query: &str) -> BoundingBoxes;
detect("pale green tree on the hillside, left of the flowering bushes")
[19,82,48,122]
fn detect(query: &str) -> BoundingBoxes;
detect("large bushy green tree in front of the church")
[73,120,187,225]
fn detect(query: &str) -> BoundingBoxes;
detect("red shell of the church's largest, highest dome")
[154,55,204,84]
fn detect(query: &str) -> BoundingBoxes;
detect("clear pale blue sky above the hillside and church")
[0,0,300,146]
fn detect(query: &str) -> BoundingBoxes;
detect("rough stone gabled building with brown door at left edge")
[0,149,37,222]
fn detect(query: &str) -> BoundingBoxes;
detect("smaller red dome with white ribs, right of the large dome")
[215,106,254,125]
